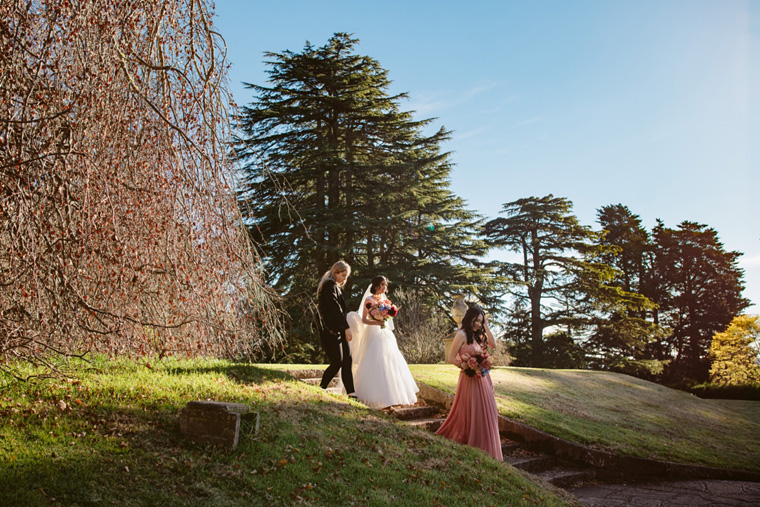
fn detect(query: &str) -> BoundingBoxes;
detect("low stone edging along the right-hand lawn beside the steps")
[417,382,760,482]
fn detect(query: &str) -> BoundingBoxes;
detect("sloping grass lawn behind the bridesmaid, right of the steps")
[410,365,760,471]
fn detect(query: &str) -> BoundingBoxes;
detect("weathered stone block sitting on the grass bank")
[179,401,249,449]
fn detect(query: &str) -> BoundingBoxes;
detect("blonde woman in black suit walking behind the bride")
[317,261,356,398]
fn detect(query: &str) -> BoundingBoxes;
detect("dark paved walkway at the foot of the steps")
[571,480,760,507]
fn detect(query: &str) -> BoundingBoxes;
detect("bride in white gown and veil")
[346,275,419,408]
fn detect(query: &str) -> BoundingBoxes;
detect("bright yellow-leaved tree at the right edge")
[710,315,760,385]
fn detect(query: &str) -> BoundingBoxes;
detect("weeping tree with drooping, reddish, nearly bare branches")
[0,0,282,378]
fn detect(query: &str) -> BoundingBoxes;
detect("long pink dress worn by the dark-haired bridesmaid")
[435,342,503,461]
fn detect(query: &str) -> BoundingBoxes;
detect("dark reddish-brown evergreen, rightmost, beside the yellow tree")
[652,221,749,380]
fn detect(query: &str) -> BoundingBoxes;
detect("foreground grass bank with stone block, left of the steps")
[0,361,566,506]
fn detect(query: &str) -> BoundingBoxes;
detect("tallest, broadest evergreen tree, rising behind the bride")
[235,33,493,358]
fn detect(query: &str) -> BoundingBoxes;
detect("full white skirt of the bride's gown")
[354,326,419,408]
